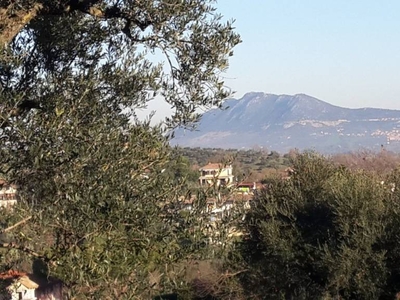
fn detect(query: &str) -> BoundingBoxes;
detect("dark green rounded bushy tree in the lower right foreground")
[240,153,400,299]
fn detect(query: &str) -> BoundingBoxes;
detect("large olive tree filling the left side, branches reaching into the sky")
[0,0,240,299]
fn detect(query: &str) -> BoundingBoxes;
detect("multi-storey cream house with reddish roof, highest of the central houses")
[199,163,234,187]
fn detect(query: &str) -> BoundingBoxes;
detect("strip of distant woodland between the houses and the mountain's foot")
[170,147,400,182]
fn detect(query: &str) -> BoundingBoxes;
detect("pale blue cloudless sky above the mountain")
[137,0,400,122]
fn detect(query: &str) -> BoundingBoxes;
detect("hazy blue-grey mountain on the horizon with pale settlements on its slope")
[171,92,400,153]
